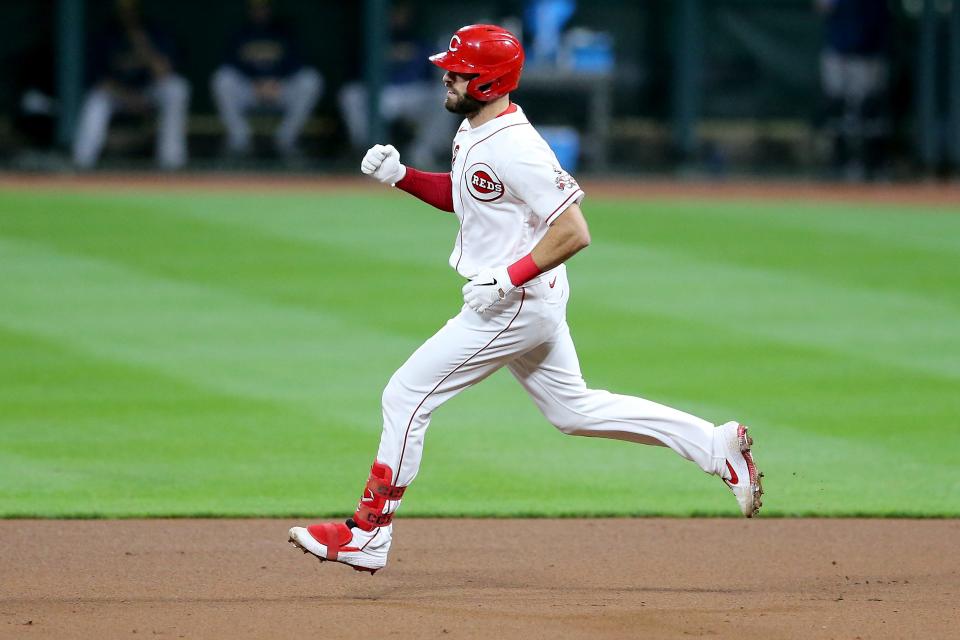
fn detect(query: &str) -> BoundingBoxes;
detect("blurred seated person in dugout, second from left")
[211,0,323,157]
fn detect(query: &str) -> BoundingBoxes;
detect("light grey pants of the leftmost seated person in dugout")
[73,75,190,169]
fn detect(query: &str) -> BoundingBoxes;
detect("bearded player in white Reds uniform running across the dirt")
[289,25,763,573]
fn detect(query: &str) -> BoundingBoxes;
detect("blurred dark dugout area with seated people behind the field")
[0,0,960,181]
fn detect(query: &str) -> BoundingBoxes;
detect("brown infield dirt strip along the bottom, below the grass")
[0,518,960,640]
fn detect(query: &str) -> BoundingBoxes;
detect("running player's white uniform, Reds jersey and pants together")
[377,105,725,513]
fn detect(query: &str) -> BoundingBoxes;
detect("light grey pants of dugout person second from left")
[210,66,323,151]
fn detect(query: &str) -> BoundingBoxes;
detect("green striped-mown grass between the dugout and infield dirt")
[0,187,960,517]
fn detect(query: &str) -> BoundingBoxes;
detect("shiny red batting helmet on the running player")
[430,24,523,102]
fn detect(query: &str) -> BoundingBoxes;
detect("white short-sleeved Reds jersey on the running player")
[450,104,584,278]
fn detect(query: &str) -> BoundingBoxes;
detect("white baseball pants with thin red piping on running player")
[377,265,724,504]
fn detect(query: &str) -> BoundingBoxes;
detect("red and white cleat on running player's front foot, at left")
[290,522,393,574]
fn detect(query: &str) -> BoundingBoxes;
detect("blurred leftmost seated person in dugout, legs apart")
[73,0,190,169]
